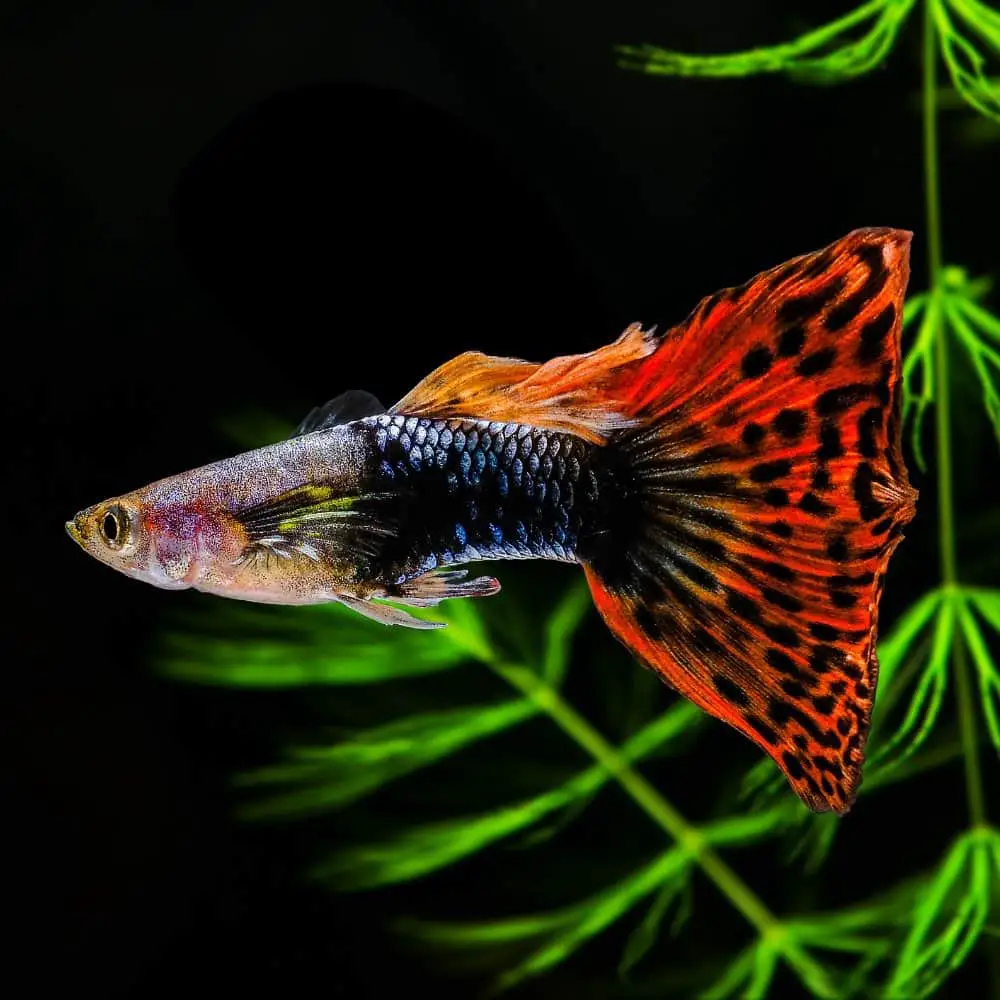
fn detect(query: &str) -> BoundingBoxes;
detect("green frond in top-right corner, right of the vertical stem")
[925,0,1000,121]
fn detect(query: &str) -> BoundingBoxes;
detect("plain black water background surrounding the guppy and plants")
[0,0,1000,998]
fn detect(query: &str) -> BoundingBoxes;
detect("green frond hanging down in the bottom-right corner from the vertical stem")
[886,828,1000,998]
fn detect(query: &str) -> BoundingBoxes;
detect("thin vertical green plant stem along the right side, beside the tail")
[923,0,986,826]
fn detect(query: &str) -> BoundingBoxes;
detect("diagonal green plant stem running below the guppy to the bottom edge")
[490,662,836,996]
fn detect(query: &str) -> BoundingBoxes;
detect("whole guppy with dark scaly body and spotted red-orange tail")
[66,228,917,814]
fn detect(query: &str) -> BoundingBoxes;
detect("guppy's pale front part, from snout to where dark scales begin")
[66,427,376,604]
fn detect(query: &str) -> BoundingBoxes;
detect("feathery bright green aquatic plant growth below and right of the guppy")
[159,0,1000,998]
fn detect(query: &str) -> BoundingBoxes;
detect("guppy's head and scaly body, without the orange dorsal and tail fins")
[67,413,614,612]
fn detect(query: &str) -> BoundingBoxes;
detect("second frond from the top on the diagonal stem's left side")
[238,699,538,819]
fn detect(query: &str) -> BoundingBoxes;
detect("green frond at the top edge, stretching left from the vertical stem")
[617,0,916,83]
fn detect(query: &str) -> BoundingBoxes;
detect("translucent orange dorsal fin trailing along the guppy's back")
[389,323,657,443]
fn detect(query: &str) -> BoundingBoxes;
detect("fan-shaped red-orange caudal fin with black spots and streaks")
[586,229,916,813]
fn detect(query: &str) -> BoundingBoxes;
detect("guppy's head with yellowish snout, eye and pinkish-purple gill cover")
[66,480,245,590]
